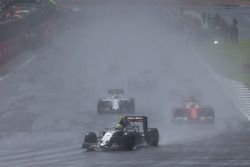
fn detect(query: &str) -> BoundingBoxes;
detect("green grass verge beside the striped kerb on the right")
[200,40,250,87]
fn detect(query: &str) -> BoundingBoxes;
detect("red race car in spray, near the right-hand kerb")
[173,97,215,123]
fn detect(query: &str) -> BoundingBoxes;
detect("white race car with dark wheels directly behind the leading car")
[97,89,135,114]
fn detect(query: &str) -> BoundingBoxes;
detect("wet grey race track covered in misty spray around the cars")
[0,5,250,167]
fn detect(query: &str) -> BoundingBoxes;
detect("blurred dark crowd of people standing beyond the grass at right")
[178,9,239,44]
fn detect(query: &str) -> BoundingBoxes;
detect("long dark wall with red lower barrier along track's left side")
[0,9,55,63]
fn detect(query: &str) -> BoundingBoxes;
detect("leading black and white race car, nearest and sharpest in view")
[82,116,159,151]
